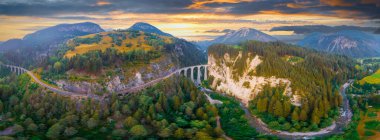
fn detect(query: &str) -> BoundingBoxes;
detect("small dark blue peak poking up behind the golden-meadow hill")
[128,22,173,37]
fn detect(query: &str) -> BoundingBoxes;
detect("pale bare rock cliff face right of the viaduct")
[208,52,299,105]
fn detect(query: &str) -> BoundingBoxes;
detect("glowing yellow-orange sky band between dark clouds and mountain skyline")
[0,10,372,41]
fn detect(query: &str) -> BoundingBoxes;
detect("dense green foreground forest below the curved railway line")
[0,75,223,139]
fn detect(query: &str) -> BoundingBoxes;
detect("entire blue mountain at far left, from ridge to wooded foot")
[0,22,104,68]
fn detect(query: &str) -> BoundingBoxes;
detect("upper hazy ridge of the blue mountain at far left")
[0,22,104,50]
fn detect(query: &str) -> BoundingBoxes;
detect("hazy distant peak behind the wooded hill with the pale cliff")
[197,28,277,49]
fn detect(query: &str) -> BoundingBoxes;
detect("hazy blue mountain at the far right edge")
[297,30,380,57]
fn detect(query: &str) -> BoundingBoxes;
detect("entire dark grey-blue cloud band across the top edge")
[0,0,380,19]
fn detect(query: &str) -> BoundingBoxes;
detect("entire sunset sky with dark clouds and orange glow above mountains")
[0,0,380,41]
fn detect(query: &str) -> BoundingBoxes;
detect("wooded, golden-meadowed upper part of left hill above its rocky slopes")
[53,30,204,73]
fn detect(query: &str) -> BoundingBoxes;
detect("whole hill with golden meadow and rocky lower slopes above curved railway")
[36,30,205,94]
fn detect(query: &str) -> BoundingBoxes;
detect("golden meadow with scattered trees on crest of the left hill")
[65,30,173,58]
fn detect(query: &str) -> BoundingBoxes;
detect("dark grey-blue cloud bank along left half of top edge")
[0,0,198,17]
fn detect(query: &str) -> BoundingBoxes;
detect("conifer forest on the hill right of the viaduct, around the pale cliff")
[209,41,356,131]
